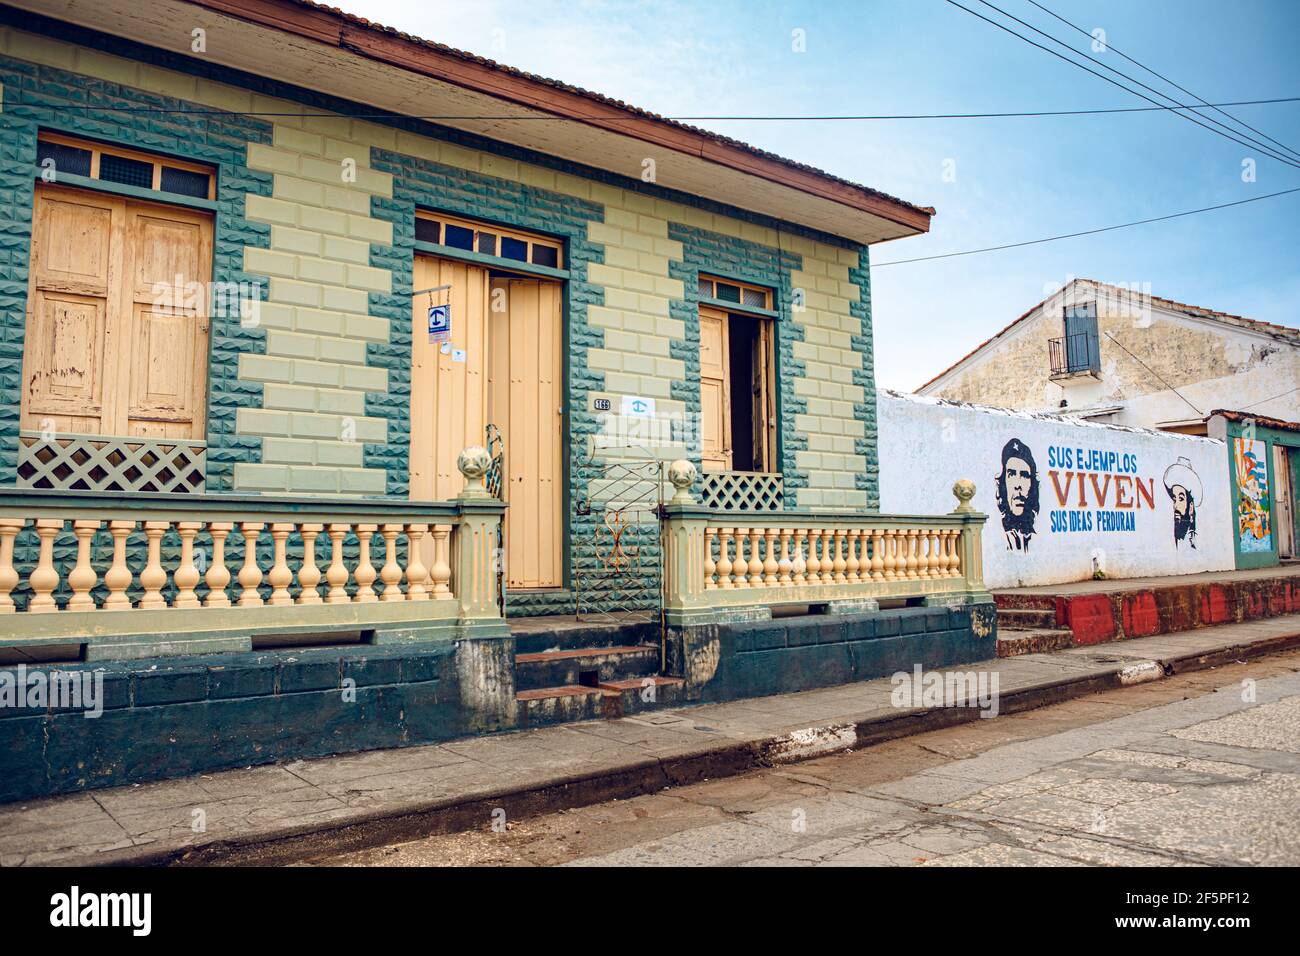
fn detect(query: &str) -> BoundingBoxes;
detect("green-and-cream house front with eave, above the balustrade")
[0,3,931,624]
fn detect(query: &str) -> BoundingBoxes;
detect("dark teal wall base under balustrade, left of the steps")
[0,644,478,801]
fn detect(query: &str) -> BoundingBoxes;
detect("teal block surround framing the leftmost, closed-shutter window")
[0,51,272,492]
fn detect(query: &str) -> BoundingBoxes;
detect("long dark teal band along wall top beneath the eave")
[0,7,857,248]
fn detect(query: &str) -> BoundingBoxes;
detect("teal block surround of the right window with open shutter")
[668,222,807,507]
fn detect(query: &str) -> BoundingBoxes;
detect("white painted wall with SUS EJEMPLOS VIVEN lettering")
[878,390,1234,588]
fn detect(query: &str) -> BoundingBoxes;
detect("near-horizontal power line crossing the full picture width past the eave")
[9,96,1300,122]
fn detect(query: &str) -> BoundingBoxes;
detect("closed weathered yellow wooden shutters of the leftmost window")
[21,186,212,438]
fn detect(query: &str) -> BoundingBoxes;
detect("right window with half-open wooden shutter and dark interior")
[699,276,776,472]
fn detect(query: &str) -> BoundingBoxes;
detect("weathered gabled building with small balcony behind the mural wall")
[917,278,1300,434]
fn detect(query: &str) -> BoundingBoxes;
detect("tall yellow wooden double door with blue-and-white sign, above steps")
[411,256,566,589]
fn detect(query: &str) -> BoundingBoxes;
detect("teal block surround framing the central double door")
[365,147,605,614]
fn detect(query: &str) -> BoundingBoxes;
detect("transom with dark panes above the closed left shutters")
[36,133,217,199]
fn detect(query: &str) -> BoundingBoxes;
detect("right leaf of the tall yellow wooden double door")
[488,278,564,588]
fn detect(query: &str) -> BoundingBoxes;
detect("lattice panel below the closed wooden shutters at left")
[18,432,208,492]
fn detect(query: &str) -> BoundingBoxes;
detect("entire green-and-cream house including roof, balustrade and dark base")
[0,0,996,800]
